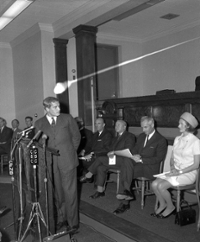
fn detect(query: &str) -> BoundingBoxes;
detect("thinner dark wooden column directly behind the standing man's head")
[53,38,69,113]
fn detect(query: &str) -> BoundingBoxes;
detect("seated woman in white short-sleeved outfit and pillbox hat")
[151,112,200,218]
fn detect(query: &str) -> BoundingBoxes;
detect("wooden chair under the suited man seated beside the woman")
[133,145,172,209]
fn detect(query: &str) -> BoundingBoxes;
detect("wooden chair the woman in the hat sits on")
[172,168,200,231]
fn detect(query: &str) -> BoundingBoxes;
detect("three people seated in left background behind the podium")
[0,116,34,160]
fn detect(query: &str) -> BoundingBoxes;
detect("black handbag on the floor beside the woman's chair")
[175,203,196,226]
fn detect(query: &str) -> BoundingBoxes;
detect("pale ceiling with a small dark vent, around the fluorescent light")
[0,0,200,43]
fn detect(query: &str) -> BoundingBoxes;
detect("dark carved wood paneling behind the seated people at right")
[97,91,200,128]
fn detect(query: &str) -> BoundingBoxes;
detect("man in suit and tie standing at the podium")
[35,97,80,231]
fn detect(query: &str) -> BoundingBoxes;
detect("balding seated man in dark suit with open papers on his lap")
[81,120,135,205]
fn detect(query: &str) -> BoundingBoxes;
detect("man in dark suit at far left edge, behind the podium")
[0,118,13,155]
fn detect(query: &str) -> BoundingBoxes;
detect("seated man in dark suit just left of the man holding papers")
[78,118,112,173]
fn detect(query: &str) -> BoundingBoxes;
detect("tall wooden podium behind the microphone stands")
[14,140,59,241]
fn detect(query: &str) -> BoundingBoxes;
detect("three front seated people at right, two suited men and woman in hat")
[80,112,200,218]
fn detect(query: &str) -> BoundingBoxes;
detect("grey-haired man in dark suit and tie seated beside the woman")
[114,116,167,214]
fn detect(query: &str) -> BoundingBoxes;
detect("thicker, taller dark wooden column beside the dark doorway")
[73,25,97,125]
